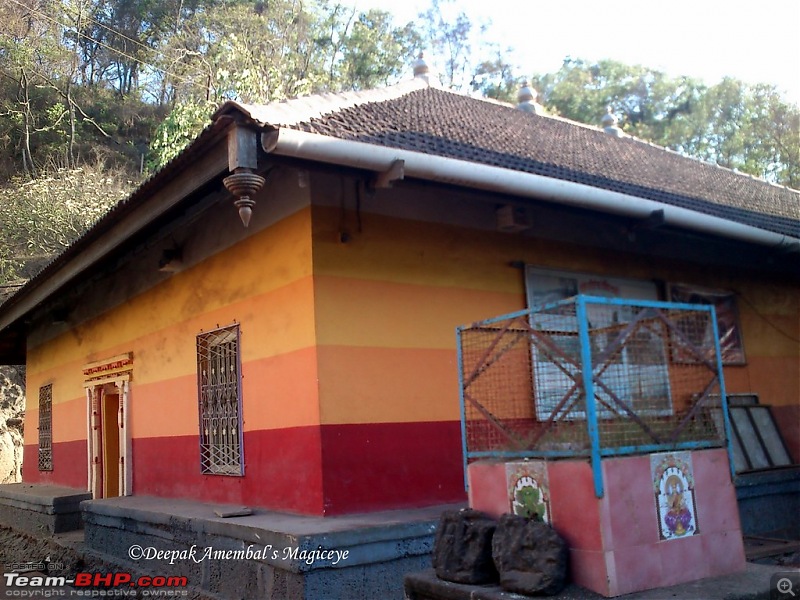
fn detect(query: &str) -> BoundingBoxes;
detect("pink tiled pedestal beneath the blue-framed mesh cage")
[468,449,745,597]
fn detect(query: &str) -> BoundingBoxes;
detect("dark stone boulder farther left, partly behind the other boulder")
[433,509,498,585]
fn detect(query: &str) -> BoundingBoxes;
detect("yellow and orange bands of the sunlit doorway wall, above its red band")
[25,207,321,505]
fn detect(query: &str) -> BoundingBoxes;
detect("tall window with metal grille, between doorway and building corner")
[197,325,244,475]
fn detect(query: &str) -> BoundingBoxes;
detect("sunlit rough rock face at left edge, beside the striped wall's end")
[0,366,25,483]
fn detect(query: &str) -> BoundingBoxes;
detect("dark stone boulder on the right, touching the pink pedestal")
[492,514,569,596]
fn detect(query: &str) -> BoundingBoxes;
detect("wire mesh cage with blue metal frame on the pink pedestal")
[458,296,727,460]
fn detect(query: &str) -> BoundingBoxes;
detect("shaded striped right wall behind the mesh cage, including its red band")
[314,199,800,510]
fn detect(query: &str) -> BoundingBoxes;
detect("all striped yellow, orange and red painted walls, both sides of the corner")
[18,172,800,515]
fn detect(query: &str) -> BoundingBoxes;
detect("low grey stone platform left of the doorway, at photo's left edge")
[0,483,92,533]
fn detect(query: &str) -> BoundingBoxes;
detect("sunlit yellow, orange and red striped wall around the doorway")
[24,208,322,513]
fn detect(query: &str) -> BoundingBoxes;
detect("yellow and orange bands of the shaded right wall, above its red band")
[314,206,800,456]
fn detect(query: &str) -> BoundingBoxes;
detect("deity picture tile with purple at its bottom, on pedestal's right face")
[650,452,699,540]
